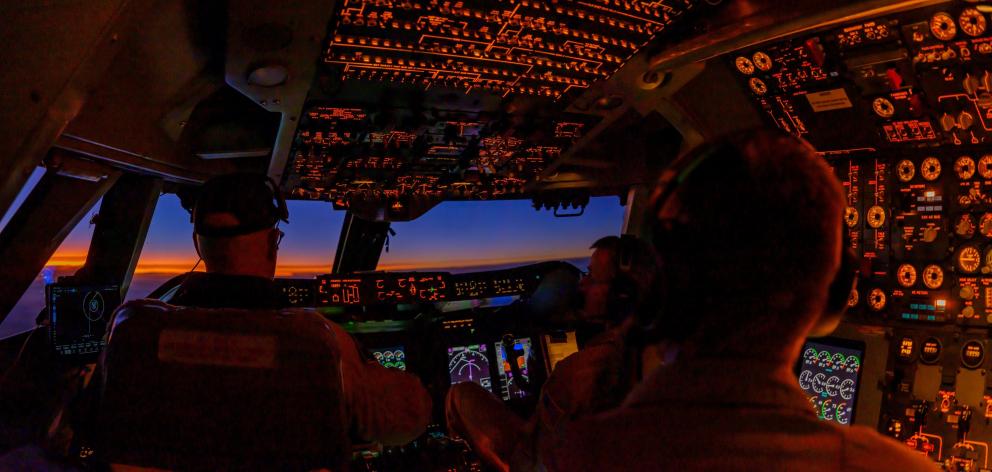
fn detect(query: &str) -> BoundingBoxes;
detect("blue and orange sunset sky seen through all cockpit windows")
[0,167,624,275]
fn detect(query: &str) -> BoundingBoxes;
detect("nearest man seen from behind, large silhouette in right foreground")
[541,130,937,471]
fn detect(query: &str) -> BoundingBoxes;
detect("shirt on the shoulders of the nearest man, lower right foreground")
[541,359,938,472]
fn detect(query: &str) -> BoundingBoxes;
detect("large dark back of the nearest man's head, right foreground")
[655,130,844,349]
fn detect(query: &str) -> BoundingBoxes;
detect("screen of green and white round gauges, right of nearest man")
[798,339,865,425]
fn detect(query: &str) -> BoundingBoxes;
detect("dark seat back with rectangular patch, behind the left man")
[93,300,350,470]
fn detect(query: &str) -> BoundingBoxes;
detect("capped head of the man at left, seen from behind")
[193,173,289,278]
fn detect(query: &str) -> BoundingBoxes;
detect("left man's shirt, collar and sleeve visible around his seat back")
[167,273,431,445]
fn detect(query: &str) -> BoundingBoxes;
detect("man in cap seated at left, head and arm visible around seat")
[169,173,431,445]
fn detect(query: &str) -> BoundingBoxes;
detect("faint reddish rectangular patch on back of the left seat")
[158,329,278,369]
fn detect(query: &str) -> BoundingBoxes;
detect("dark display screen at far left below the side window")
[46,283,121,357]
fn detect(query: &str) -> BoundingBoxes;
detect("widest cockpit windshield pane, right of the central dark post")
[378,197,624,272]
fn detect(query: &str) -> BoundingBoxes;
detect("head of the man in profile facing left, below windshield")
[579,235,655,322]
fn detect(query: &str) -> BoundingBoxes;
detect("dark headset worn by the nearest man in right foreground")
[635,130,860,342]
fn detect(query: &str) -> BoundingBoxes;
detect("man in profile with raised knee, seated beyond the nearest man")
[445,235,655,470]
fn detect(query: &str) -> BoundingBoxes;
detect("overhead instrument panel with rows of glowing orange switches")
[283,0,694,209]
